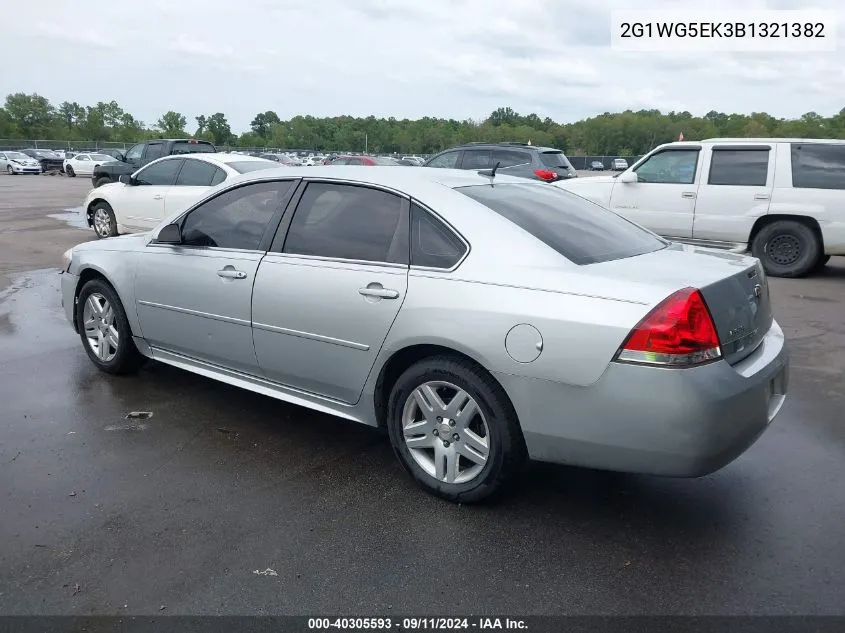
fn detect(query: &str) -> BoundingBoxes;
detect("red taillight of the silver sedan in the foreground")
[616,288,722,367]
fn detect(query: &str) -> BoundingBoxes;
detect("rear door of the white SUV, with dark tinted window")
[692,144,777,243]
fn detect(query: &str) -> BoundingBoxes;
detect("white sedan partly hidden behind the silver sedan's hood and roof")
[82,153,278,238]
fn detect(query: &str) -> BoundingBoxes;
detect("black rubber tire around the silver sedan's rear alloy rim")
[387,356,527,503]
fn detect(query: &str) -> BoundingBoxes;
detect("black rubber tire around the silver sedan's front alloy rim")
[76,279,146,374]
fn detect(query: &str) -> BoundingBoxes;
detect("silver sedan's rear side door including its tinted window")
[252,182,410,403]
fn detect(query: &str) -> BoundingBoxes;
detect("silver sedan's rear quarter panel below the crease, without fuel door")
[382,271,649,386]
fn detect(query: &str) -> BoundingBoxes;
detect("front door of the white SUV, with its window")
[610,147,700,238]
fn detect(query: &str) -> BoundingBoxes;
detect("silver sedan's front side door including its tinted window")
[135,181,292,374]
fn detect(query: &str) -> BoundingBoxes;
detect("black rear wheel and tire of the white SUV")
[751,220,822,277]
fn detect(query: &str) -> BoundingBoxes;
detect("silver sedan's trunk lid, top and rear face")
[585,244,773,364]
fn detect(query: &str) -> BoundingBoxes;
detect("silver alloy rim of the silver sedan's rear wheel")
[402,381,491,484]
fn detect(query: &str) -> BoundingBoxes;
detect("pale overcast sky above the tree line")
[0,0,845,132]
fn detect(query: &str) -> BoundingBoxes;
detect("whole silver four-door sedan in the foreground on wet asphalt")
[61,167,787,502]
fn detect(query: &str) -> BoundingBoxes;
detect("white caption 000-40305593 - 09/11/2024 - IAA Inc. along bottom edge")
[308,617,528,631]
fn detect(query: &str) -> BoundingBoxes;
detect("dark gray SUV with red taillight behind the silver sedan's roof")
[423,143,578,182]
